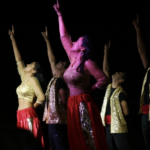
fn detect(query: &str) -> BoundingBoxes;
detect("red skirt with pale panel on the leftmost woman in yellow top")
[17,107,44,147]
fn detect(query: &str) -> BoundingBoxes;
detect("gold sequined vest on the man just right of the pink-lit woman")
[100,84,128,133]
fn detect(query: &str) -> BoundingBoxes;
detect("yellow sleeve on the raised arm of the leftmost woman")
[17,61,25,81]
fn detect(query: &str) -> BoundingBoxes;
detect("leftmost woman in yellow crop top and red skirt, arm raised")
[9,26,45,147]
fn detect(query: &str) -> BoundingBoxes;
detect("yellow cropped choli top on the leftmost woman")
[16,61,40,102]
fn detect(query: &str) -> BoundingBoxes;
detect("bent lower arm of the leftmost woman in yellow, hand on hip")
[29,77,45,108]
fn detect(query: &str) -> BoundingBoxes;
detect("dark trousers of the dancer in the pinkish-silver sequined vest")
[48,124,69,150]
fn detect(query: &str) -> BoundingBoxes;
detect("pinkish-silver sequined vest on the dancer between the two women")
[43,77,67,124]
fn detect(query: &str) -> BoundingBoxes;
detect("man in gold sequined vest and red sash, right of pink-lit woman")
[100,42,130,150]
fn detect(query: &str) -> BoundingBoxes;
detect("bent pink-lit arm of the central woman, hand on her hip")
[85,60,108,89]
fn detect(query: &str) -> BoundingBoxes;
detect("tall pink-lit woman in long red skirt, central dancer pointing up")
[54,1,108,150]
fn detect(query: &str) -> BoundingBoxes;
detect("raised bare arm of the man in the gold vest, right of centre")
[103,41,110,80]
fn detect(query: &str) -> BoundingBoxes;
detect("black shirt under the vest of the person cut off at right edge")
[143,64,150,105]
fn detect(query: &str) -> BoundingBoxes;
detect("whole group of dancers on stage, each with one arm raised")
[9,0,150,150]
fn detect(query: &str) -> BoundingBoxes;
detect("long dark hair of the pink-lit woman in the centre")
[77,35,94,73]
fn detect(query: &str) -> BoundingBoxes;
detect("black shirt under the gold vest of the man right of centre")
[105,88,127,116]
